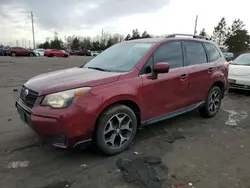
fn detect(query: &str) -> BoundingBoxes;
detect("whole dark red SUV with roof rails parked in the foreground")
[16,35,228,155]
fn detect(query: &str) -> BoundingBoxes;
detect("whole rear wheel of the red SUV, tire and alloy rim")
[199,86,222,118]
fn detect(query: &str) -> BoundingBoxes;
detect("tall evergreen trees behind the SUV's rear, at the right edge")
[199,17,250,56]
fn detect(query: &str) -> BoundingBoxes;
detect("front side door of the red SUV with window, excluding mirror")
[140,41,188,120]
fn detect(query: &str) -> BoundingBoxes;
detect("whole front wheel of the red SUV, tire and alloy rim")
[96,104,137,155]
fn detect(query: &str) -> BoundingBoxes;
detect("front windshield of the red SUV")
[83,42,154,72]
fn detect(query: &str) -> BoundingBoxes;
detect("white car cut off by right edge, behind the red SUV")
[228,53,250,91]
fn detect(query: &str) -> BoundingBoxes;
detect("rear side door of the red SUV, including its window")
[182,41,211,105]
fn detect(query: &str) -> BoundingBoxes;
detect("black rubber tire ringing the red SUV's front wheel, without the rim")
[96,105,137,155]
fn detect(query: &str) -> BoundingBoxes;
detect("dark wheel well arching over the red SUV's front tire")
[93,100,141,136]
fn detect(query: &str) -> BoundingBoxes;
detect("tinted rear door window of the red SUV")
[183,41,207,66]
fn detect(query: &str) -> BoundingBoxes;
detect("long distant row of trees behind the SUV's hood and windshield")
[38,29,151,51]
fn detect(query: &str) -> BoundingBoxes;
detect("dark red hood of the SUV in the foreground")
[24,67,121,95]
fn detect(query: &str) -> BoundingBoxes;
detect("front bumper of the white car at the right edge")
[228,77,250,91]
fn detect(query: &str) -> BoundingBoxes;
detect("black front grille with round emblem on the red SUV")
[20,86,38,108]
